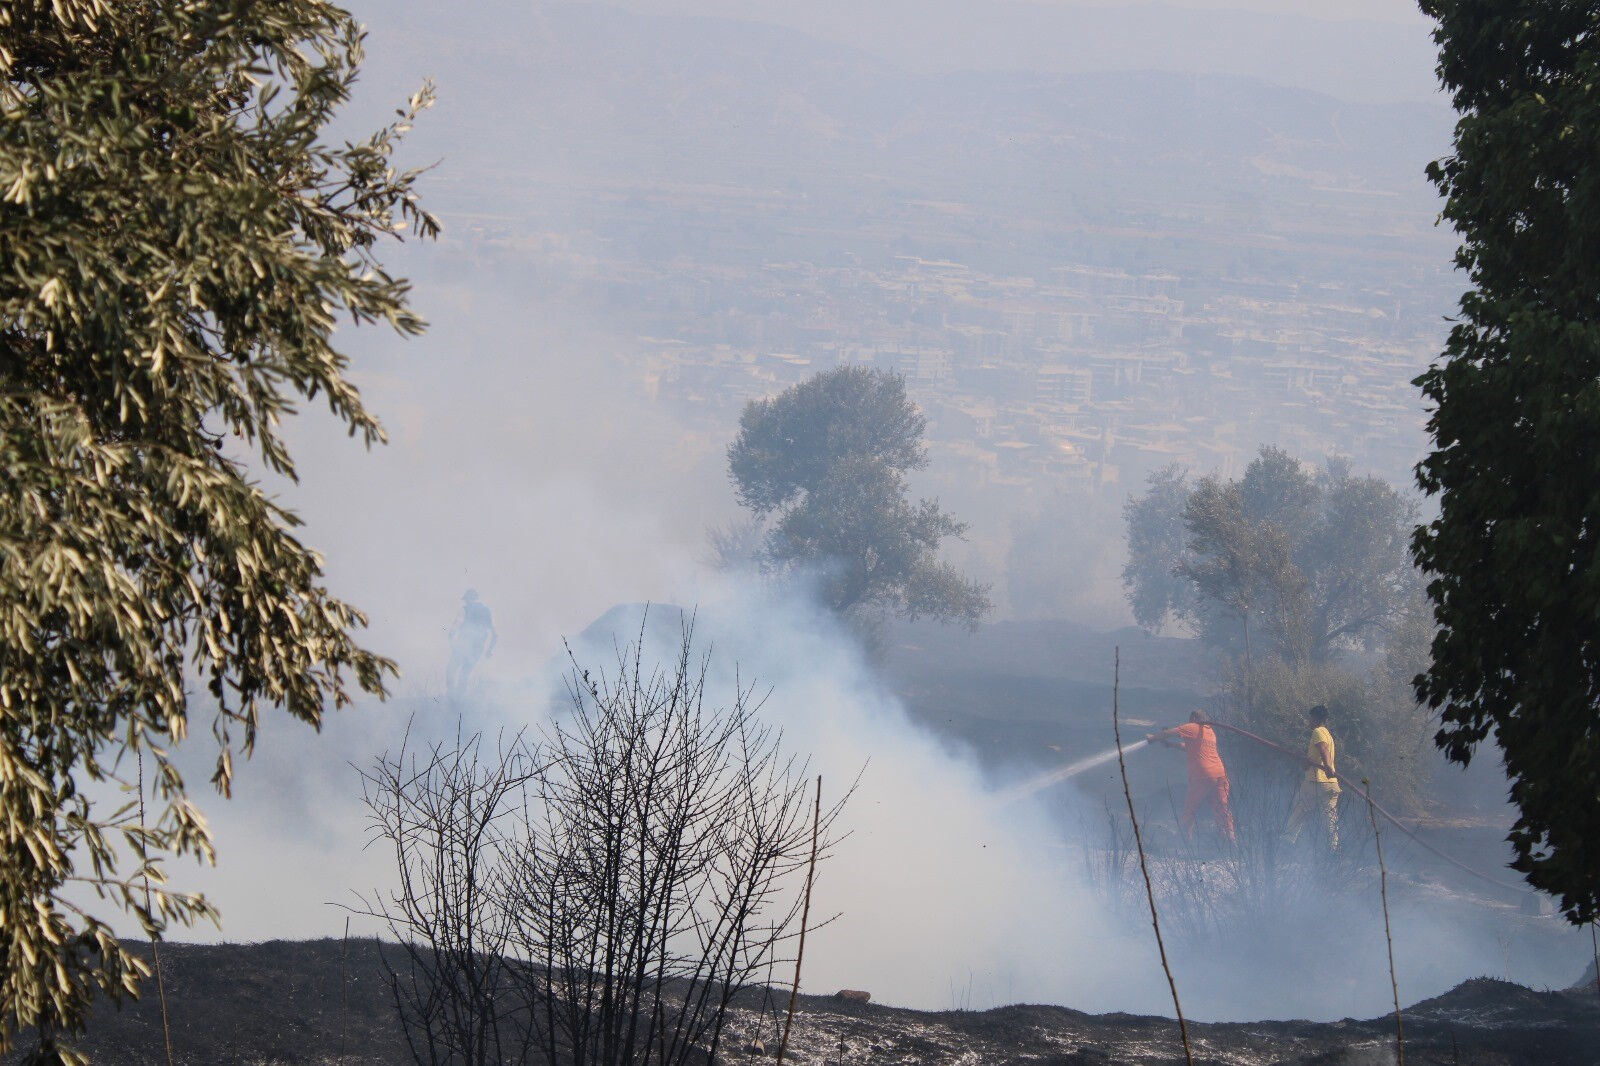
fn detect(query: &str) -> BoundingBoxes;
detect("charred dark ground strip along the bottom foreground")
[21,940,1600,1066]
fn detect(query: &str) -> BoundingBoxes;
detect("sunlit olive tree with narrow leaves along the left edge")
[0,0,437,1061]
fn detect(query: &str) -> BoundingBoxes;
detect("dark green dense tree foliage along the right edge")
[1414,0,1600,922]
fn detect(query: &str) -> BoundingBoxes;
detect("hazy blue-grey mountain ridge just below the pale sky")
[356,3,1453,221]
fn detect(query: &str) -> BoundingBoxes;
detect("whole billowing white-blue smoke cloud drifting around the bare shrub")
[116,238,1582,1018]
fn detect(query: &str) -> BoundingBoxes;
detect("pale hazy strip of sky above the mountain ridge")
[368,0,1438,102]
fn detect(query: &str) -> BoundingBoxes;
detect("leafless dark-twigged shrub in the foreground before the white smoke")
[356,624,848,1066]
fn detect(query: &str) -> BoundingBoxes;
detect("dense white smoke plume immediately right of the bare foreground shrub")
[553,581,1160,1010]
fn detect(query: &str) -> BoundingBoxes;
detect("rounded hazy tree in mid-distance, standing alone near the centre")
[728,367,989,624]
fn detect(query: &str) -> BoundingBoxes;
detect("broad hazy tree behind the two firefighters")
[1123,448,1426,795]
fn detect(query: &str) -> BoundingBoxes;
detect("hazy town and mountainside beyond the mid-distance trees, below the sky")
[368,5,1462,616]
